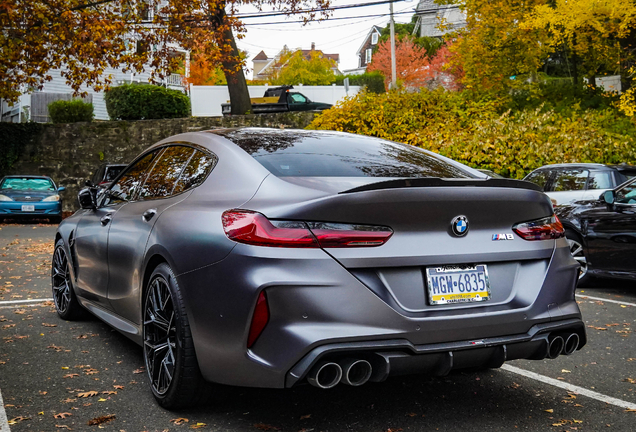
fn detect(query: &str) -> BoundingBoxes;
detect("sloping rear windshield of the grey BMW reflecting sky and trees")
[214,129,485,178]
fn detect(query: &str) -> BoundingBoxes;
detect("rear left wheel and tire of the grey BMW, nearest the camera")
[142,263,208,410]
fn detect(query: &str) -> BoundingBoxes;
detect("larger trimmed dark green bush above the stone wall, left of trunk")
[104,84,190,120]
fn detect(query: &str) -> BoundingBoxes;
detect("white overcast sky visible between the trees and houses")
[237,0,418,78]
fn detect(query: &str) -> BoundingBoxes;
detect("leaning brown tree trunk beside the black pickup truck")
[219,2,252,115]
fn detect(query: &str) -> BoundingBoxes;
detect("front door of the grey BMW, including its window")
[73,152,157,308]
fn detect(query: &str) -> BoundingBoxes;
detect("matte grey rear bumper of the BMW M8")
[177,239,585,388]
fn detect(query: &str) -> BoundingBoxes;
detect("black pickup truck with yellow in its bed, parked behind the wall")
[221,86,332,115]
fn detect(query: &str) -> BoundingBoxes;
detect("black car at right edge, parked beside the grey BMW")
[556,178,636,285]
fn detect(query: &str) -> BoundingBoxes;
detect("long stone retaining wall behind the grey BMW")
[8,112,316,211]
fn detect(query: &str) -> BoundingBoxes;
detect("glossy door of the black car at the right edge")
[582,182,636,274]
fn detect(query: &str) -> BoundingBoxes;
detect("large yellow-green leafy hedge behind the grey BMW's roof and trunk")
[308,89,636,178]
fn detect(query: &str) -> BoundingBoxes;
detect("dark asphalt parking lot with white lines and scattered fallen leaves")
[0,223,636,432]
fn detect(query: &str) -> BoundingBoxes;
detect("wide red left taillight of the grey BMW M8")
[222,210,393,248]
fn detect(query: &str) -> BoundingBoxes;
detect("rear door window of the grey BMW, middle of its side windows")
[139,146,194,199]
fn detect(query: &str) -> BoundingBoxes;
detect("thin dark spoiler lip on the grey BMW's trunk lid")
[340,177,543,194]
